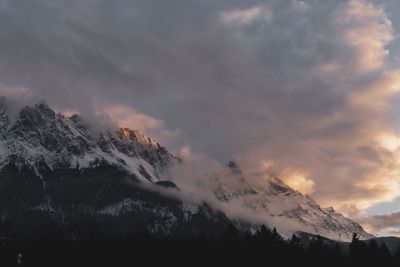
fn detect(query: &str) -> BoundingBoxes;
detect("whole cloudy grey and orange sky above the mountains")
[0,0,400,235]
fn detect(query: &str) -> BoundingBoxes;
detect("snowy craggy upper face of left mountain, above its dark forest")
[0,99,173,182]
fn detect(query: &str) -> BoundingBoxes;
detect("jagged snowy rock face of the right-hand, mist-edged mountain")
[209,168,373,241]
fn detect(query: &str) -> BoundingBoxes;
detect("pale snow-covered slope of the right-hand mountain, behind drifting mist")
[172,162,373,241]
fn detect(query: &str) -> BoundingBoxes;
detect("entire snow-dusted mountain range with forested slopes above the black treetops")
[0,98,372,240]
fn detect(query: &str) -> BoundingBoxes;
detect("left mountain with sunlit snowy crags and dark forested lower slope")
[0,99,231,240]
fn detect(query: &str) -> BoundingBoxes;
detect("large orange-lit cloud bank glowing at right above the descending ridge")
[227,0,400,216]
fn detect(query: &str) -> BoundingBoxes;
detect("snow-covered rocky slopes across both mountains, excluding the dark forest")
[0,99,372,240]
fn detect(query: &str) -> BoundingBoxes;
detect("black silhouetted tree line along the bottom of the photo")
[0,225,400,266]
